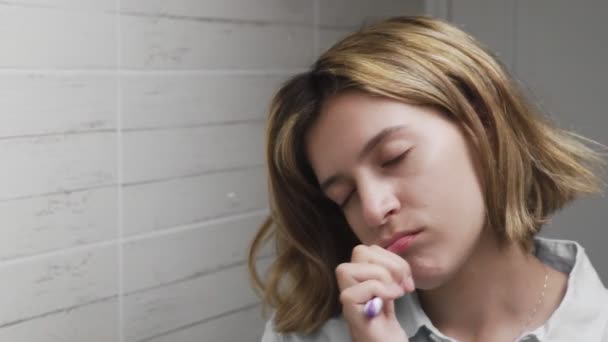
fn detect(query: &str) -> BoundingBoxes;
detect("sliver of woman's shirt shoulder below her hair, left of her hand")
[261,316,351,342]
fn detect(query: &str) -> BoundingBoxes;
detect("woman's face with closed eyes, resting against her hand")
[306,92,485,289]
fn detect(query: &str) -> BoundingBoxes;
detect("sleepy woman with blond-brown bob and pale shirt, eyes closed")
[250,17,608,341]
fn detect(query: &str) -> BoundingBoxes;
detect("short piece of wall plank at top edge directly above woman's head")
[319,0,424,28]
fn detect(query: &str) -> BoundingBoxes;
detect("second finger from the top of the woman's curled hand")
[336,262,400,290]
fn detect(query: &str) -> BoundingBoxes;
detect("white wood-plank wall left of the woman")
[0,0,422,342]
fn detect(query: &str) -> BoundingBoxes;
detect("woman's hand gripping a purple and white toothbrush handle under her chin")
[336,245,415,342]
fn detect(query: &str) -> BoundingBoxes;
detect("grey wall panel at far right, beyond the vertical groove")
[515,0,608,284]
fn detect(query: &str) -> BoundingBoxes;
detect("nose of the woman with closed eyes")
[358,178,401,227]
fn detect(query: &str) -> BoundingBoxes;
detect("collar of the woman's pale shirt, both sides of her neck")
[395,237,608,340]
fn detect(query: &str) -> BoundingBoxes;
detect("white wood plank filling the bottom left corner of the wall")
[0,298,118,342]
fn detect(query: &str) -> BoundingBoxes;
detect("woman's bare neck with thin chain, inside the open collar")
[418,229,548,336]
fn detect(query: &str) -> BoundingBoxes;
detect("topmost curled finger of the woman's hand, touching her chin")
[351,245,415,292]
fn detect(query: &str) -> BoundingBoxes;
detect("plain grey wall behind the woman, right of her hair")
[427,0,608,284]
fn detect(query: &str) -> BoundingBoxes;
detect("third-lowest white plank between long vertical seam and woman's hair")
[124,213,267,293]
